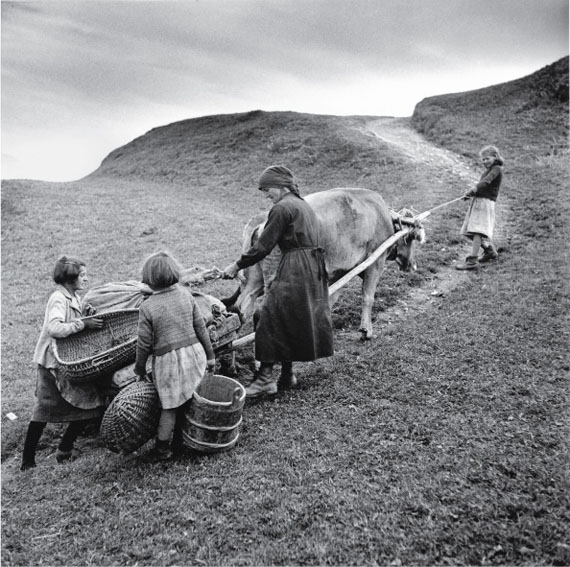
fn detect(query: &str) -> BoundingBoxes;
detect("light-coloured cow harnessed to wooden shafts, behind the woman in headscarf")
[223,188,425,340]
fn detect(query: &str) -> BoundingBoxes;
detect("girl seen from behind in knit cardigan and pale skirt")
[135,252,216,460]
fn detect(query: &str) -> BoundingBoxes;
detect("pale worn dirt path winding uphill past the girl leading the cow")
[360,118,508,325]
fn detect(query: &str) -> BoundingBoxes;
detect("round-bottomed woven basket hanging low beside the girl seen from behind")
[101,382,160,455]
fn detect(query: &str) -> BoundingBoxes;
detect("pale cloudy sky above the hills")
[0,0,568,181]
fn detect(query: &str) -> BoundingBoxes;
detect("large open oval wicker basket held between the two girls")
[52,309,139,383]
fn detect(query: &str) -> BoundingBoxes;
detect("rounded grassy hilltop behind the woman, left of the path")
[89,110,404,191]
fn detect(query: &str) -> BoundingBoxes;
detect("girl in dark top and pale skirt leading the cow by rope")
[456,146,504,270]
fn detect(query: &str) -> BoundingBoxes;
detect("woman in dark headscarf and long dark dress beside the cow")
[220,165,333,397]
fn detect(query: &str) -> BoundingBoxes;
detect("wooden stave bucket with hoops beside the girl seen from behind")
[182,374,245,453]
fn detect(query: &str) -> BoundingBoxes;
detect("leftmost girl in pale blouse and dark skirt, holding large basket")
[20,256,105,470]
